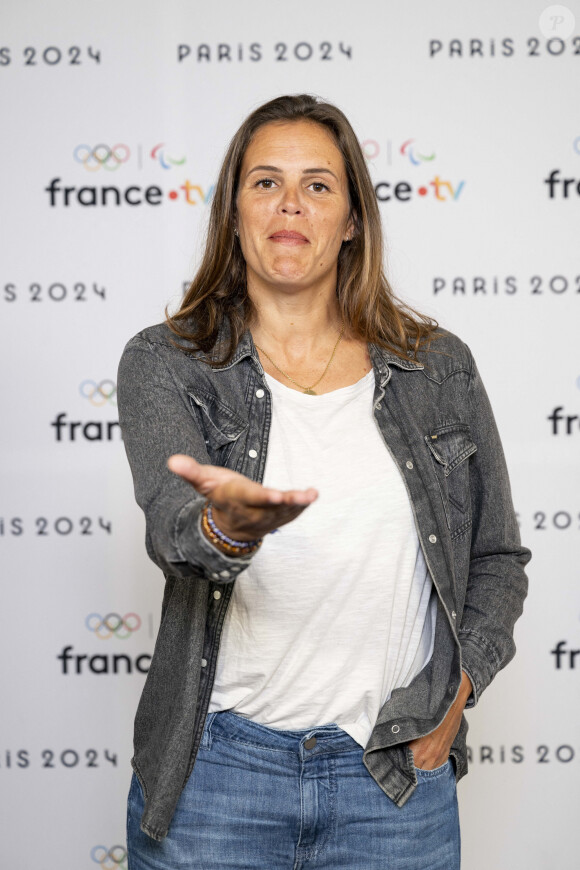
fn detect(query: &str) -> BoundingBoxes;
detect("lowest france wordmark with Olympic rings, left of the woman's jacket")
[56,613,151,676]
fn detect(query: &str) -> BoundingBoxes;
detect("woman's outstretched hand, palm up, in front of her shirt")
[167,453,318,541]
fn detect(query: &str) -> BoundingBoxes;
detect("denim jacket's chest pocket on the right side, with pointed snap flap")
[425,423,477,536]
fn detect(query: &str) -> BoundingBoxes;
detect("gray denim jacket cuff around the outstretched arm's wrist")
[174,498,253,583]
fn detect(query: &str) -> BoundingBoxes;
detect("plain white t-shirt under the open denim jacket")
[209,371,436,747]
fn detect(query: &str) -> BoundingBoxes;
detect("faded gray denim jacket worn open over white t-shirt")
[118,325,530,840]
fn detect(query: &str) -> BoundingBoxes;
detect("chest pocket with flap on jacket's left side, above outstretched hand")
[187,385,248,465]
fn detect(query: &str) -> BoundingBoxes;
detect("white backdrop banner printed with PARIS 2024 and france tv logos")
[0,0,580,870]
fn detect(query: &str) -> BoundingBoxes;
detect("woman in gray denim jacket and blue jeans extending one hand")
[119,96,529,870]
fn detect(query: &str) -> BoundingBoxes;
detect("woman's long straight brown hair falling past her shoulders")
[166,94,437,365]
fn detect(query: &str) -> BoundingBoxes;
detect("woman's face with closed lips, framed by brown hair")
[237,121,353,294]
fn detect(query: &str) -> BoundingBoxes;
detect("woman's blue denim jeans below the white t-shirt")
[127,712,460,870]
